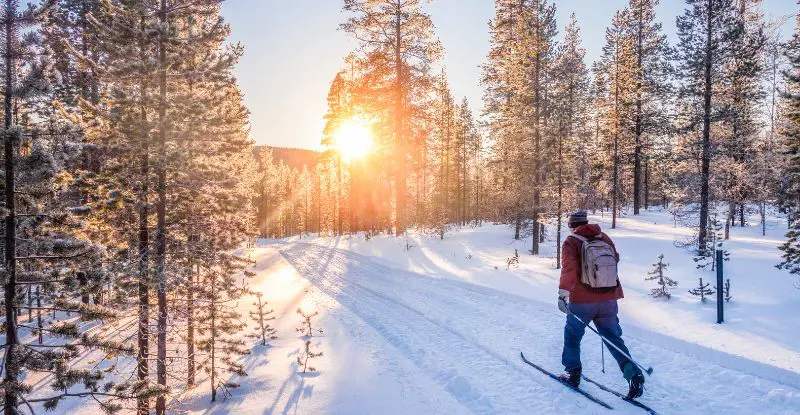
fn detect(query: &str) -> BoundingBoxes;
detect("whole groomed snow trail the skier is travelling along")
[278,243,800,414]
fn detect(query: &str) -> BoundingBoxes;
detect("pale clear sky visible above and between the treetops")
[222,0,800,149]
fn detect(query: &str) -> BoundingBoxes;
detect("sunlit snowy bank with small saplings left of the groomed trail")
[174,247,468,414]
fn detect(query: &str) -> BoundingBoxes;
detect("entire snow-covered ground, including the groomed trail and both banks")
[57,212,800,414]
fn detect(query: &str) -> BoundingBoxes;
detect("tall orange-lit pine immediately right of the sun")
[341,0,442,236]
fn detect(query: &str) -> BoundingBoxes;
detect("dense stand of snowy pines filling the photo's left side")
[0,0,256,414]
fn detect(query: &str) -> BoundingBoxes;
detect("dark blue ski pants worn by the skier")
[561,300,642,380]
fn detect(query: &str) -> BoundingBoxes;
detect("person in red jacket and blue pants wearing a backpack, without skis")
[558,210,644,399]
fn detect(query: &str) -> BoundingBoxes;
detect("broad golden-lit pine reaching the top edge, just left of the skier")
[483,0,557,247]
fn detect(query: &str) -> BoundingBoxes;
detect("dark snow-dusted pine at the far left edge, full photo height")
[1,0,158,414]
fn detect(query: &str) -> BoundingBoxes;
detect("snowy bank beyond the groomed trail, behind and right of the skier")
[296,208,800,380]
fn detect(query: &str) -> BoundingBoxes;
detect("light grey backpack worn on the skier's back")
[570,234,618,288]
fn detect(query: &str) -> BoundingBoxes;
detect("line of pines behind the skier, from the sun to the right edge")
[260,0,797,268]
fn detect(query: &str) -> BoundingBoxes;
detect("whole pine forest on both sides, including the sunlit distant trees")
[0,0,800,415]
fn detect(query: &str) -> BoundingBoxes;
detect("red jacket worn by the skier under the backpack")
[558,224,623,303]
